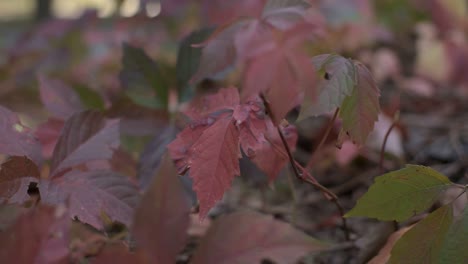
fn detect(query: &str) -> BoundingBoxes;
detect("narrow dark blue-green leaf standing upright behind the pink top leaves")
[176,28,213,101]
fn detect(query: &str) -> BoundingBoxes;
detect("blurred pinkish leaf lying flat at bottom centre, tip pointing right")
[192,212,327,264]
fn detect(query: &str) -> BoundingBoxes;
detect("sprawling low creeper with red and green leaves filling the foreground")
[0,0,468,264]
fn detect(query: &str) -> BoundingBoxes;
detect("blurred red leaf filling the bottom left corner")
[0,205,70,264]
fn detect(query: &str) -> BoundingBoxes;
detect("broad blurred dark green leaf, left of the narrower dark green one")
[119,43,169,109]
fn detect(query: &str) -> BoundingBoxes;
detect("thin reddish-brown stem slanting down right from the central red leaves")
[260,94,350,241]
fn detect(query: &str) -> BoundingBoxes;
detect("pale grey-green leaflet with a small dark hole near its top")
[298,54,357,121]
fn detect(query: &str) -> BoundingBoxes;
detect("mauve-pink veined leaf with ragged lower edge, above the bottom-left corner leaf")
[39,171,139,229]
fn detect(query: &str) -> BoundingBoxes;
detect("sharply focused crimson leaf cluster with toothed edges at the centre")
[168,87,297,217]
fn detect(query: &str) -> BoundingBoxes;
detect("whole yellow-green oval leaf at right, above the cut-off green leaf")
[345,165,452,221]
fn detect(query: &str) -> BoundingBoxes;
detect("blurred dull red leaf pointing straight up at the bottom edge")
[133,157,190,263]
